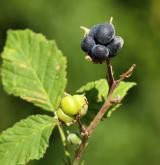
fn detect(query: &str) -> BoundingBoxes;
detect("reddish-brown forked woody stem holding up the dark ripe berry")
[73,60,136,165]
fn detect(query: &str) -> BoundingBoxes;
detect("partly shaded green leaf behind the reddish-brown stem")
[77,79,135,124]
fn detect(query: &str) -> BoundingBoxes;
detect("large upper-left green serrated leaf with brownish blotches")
[2,30,66,111]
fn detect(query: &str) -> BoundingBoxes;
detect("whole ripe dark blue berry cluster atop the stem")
[81,23,124,63]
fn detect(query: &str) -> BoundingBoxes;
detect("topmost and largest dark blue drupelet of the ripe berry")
[94,23,115,45]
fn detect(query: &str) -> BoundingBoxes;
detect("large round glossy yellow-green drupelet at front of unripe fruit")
[61,96,79,116]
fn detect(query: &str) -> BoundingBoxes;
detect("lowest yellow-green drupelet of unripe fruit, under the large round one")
[56,108,74,124]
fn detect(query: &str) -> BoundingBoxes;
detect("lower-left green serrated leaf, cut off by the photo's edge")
[0,115,56,165]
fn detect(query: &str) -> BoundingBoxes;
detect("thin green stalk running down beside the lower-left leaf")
[57,121,71,165]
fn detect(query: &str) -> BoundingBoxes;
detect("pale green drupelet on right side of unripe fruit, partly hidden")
[73,95,88,116]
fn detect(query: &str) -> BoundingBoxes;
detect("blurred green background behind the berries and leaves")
[0,0,160,165]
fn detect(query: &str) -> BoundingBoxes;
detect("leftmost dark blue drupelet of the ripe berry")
[81,36,96,55]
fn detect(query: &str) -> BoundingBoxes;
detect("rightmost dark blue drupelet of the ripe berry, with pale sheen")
[107,36,124,57]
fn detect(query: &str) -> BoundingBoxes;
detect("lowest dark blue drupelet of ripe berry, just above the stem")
[91,45,109,63]
